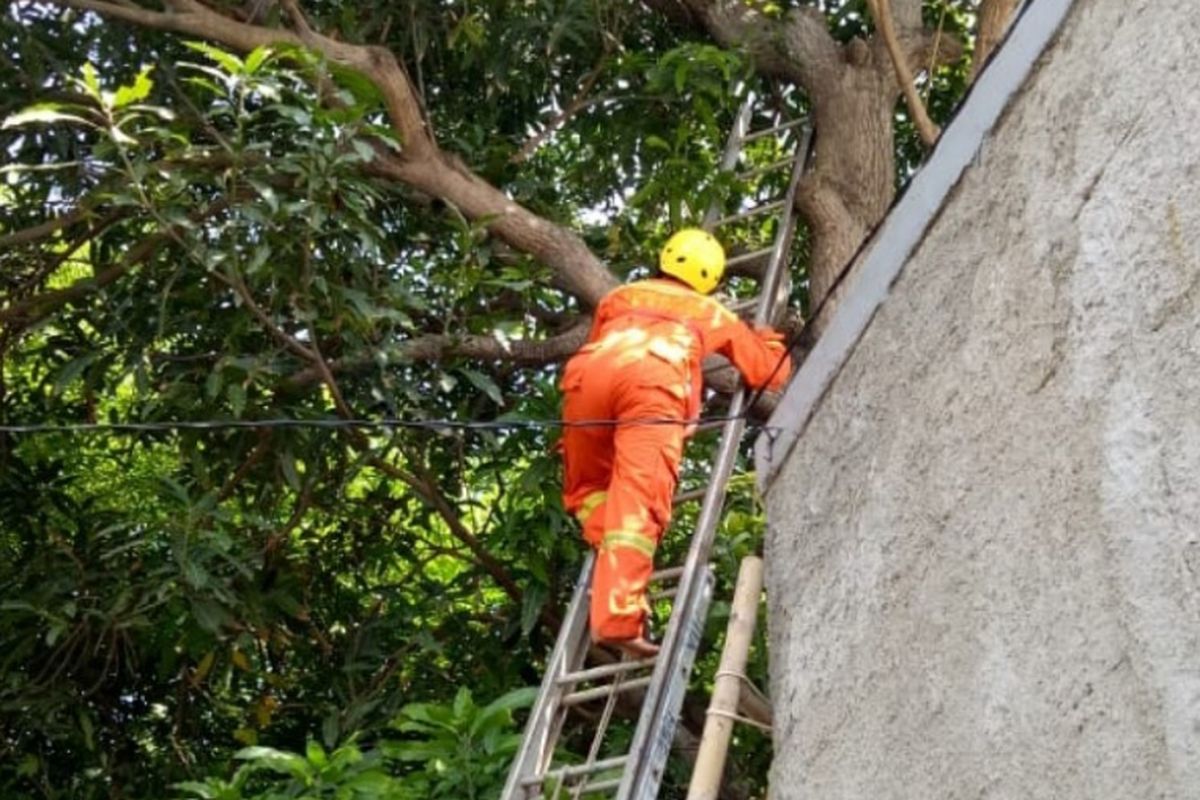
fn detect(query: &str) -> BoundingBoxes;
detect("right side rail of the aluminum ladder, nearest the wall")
[617,115,808,800]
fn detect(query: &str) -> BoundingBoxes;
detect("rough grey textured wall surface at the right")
[767,0,1200,800]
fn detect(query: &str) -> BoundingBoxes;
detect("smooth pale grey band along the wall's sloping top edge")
[755,0,1073,492]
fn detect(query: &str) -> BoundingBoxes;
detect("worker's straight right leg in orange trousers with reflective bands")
[589,386,684,642]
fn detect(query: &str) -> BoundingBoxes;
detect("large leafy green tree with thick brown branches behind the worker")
[0,0,1017,796]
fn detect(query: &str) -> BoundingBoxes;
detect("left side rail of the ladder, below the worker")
[500,551,595,800]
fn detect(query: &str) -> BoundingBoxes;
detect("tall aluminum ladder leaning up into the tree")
[500,94,811,800]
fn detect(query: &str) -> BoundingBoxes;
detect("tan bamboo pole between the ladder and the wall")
[688,555,762,800]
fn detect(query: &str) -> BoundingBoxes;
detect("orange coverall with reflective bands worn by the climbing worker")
[562,278,791,642]
